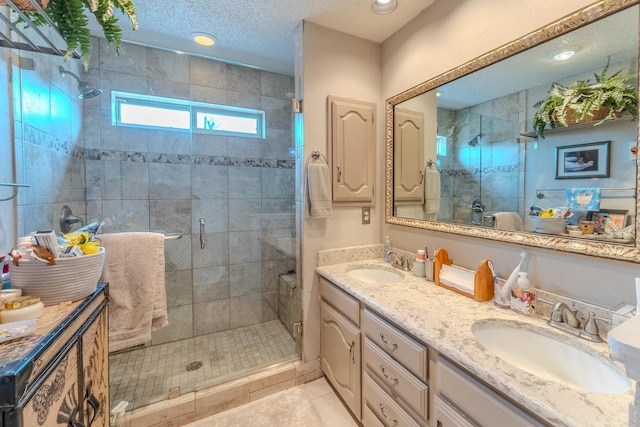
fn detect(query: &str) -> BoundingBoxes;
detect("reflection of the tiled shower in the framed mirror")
[437,95,526,226]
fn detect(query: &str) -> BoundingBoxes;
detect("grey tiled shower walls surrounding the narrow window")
[13,40,295,344]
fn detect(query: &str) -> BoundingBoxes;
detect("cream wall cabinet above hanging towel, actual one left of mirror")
[327,96,376,205]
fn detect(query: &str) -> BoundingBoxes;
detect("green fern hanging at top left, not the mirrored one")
[5,0,138,70]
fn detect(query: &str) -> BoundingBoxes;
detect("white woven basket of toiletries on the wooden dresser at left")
[9,248,105,305]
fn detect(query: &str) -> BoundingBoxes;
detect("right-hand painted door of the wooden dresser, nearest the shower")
[81,306,109,427]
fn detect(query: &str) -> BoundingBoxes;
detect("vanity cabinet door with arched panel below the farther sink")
[320,302,361,419]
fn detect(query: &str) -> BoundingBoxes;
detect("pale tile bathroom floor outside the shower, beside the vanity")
[186,378,358,427]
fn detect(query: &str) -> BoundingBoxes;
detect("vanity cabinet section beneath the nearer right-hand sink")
[432,356,550,427]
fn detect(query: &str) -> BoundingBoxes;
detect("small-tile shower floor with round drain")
[109,320,299,410]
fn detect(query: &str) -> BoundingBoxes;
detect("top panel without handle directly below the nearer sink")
[436,357,544,427]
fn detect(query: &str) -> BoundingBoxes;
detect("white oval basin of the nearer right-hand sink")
[471,319,631,394]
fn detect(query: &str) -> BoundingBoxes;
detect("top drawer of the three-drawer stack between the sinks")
[362,310,427,382]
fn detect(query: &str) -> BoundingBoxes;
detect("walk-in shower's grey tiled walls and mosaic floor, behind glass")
[9,40,301,410]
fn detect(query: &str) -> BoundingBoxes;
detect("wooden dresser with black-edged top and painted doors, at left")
[0,283,109,427]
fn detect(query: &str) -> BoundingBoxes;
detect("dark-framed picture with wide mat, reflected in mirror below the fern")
[556,141,611,179]
